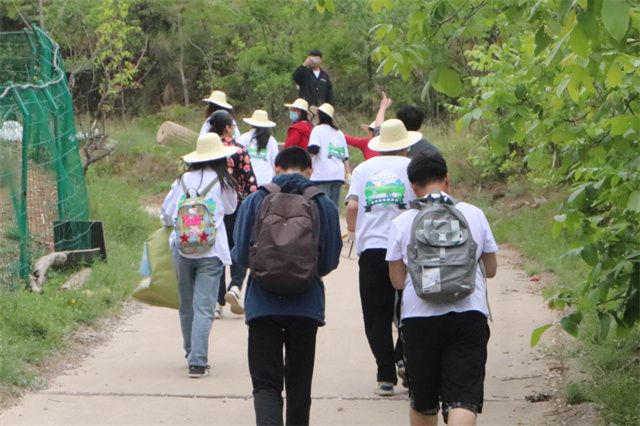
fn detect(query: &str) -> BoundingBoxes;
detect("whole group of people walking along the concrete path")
[161,51,497,425]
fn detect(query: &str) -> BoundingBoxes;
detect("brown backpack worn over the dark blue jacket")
[249,183,323,295]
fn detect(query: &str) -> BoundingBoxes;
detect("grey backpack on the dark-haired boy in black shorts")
[407,190,478,303]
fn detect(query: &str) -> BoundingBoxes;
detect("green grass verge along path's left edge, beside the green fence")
[0,168,157,391]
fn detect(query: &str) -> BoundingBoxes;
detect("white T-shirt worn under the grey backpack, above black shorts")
[386,193,498,318]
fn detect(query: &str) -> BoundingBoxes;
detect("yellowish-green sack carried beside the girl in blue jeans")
[133,226,180,309]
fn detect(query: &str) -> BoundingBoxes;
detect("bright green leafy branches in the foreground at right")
[368,0,640,341]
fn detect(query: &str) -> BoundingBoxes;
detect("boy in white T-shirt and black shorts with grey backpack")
[386,153,498,426]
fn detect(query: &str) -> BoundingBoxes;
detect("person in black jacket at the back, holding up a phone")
[291,49,333,106]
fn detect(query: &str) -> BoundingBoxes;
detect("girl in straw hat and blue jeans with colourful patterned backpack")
[161,134,237,378]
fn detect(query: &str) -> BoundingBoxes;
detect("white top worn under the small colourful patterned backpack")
[160,169,238,265]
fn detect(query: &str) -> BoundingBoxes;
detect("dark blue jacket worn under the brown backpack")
[231,173,342,325]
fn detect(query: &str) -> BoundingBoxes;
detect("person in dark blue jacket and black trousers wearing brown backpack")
[232,147,342,425]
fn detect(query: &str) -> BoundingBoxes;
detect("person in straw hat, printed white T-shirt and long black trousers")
[346,119,422,396]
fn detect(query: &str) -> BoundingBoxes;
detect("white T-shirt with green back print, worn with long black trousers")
[347,155,416,254]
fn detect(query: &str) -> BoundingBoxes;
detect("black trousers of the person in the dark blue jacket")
[249,316,319,425]
